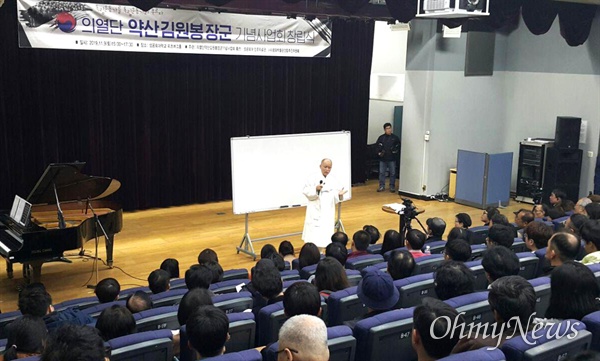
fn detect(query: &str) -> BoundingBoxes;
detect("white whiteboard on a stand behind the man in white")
[231,131,352,214]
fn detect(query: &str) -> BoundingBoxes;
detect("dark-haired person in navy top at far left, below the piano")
[19,283,94,331]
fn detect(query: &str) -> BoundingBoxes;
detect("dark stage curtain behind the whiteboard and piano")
[0,1,374,210]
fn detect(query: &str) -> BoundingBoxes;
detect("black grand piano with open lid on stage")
[0,162,123,282]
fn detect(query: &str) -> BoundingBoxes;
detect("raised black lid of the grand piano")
[27,162,121,204]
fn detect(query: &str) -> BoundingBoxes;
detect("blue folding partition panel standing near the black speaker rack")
[454,149,513,209]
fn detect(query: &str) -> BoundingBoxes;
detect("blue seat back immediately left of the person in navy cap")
[327,287,367,326]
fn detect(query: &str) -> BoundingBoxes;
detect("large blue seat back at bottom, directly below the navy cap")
[354,308,417,361]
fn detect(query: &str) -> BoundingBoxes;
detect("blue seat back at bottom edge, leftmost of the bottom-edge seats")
[108,330,173,361]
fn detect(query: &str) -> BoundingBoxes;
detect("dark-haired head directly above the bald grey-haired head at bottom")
[283,282,321,317]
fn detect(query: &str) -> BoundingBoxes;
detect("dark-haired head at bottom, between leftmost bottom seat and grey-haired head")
[185,306,229,359]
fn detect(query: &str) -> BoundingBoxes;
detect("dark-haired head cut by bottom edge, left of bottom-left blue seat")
[40,324,108,361]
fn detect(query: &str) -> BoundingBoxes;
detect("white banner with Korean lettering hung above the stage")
[17,0,331,57]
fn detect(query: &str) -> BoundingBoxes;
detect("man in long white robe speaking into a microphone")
[302,159,348,248]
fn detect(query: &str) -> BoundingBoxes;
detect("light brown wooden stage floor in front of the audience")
[0,180,531,312]
